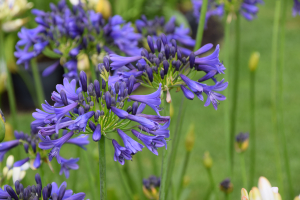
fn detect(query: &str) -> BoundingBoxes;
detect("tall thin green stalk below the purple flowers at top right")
[230,14,241,175]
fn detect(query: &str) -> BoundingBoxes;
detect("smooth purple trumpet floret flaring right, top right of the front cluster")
[129,83,161,115]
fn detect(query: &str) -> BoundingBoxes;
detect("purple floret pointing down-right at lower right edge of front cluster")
[131,129,167,155]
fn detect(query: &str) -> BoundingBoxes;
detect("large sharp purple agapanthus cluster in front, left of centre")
[32,70,170,164]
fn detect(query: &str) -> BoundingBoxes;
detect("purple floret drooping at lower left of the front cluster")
[39,131,74,163]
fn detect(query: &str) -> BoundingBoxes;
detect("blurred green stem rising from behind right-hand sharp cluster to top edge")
[194,0,208,51]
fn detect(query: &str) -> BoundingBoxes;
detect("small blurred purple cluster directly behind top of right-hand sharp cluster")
[135,15,195,55]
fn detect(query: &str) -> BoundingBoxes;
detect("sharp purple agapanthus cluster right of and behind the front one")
[110,34,228,109]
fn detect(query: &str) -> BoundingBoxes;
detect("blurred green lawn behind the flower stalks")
[2,0,300,199]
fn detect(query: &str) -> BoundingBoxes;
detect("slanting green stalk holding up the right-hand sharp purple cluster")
[160,96,186,199]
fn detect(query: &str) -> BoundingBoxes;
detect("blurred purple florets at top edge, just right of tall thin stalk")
[240,0,264,21]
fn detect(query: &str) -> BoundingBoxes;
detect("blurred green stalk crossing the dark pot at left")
[30,59,45,107]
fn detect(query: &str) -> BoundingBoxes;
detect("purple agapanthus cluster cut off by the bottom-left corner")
[0,174,85,200]
